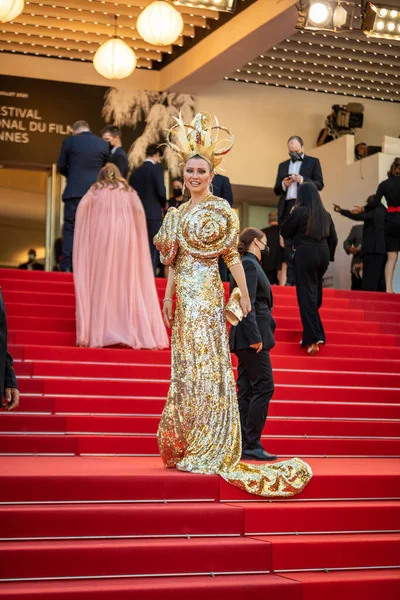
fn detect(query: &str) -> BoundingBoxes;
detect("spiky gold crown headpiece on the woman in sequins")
[166,113,234,170]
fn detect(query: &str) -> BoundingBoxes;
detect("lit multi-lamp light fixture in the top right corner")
[362,0,400,40]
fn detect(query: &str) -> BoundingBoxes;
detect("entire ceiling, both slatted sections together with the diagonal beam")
[0,0,400,102]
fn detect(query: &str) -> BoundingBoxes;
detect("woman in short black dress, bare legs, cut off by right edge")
[355,157,400,294]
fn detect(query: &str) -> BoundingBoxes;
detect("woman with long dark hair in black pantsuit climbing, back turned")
[281,183,337,356]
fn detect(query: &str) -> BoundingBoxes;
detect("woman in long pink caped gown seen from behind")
[73,163,168,348]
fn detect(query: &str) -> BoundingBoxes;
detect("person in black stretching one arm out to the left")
[333,196,386,292]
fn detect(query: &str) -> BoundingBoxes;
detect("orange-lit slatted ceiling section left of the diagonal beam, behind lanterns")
[0,0,225,69]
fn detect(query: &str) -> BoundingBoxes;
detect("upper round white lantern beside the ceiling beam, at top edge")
[136,0,183,46]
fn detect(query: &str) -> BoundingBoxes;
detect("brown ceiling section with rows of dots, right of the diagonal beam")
[225,18,400,102]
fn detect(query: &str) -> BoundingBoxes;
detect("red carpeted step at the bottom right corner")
[285,569,400,600]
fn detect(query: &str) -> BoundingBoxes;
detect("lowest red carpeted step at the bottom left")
[1,574,300,600]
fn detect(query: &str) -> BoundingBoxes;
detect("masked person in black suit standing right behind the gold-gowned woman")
[229,227,277,460]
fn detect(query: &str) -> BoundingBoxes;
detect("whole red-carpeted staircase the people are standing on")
[0,270,400,600]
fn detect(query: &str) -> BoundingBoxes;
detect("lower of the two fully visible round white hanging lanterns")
[93,38,137,79]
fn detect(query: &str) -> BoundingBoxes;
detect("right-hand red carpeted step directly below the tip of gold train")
[230,500,400,535]
